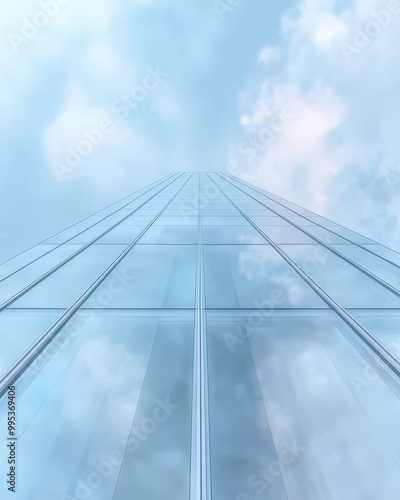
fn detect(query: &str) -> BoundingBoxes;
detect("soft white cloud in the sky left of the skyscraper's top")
[43,87,146,187]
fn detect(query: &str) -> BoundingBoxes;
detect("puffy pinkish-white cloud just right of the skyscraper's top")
[245,79,343,212]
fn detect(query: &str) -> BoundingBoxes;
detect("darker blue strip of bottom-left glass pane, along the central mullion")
[113,324,193,500]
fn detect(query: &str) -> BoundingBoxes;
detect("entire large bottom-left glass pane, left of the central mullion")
[0,315,193,500]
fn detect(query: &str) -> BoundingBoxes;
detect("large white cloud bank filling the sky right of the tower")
[234,0,400,249]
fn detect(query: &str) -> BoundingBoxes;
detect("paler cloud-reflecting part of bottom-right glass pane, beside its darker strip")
[247,318,400,500]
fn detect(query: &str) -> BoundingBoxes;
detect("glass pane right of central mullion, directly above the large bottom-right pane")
[204,245,327,310]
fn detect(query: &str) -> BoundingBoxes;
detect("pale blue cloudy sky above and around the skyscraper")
[0,0,400,260]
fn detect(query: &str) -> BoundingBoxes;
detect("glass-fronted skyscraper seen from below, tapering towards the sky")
[0,173,400,500]
